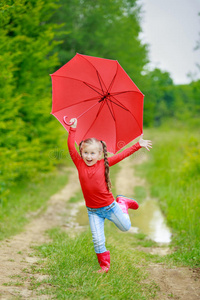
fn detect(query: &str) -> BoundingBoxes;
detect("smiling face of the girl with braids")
[81,144,102,167]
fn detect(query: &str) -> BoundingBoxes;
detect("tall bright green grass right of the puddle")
[138,129,200,267]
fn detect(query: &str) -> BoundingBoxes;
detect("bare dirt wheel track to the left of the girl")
[0,168,80,300]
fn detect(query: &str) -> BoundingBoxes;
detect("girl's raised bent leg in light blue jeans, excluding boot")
[106,202,131,231]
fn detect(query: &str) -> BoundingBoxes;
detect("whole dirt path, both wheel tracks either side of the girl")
[0,158,200,300]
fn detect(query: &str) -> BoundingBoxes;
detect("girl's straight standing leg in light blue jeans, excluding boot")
[87,208,107,253]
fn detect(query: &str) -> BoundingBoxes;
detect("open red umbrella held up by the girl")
[51,54,144,153]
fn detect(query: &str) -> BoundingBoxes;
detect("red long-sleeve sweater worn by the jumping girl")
[68,127,141,208]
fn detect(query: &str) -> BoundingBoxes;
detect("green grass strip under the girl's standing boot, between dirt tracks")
[36,227,158,300]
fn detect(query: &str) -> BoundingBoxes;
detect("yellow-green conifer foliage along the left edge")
[0,0,64,201]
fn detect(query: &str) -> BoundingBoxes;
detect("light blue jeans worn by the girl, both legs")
[87,201,131,253]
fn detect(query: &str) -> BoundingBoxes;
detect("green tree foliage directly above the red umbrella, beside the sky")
[49,0,147,82]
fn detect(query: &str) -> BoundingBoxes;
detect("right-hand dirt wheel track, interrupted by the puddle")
[116,150,200,300]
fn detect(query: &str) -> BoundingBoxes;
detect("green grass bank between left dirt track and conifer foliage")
[0,171,68,240]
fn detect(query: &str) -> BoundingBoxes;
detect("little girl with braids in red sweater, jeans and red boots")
[68,119,152,273]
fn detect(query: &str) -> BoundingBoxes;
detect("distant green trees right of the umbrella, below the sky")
[141,69,200,128]
